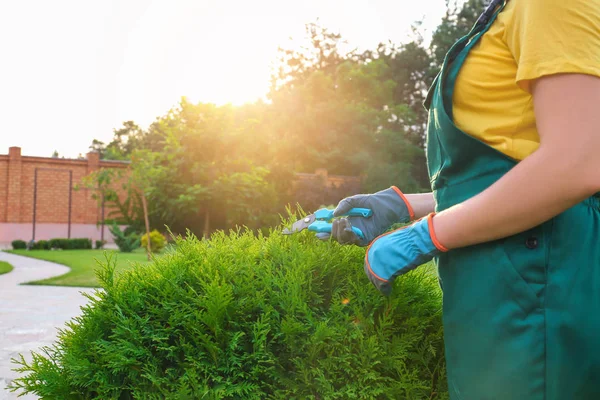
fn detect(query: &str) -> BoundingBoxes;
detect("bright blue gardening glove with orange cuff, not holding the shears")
[365,213,448,296]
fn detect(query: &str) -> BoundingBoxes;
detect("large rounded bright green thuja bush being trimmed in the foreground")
[12,222,447,399]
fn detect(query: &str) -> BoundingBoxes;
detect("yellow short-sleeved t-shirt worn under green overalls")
[453,0,600,160]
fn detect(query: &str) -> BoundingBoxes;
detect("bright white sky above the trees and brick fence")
[0,0,445,158]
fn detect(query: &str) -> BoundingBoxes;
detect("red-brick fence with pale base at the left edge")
[0,147,127,243]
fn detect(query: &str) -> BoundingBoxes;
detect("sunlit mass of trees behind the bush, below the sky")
[85,0,485,234]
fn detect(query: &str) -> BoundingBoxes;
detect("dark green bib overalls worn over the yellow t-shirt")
[425,0,600,400]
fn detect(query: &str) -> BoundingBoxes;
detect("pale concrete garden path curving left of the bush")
[0,251,93,400]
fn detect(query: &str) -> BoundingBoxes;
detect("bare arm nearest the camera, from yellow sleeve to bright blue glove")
[433,74,600,249]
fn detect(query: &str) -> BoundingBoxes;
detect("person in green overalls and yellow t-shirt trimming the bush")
[321,0,600,400]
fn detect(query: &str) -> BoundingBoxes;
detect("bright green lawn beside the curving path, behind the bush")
[5,249,155,287]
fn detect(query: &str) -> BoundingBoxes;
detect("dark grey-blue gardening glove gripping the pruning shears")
[317,186,415,246]
